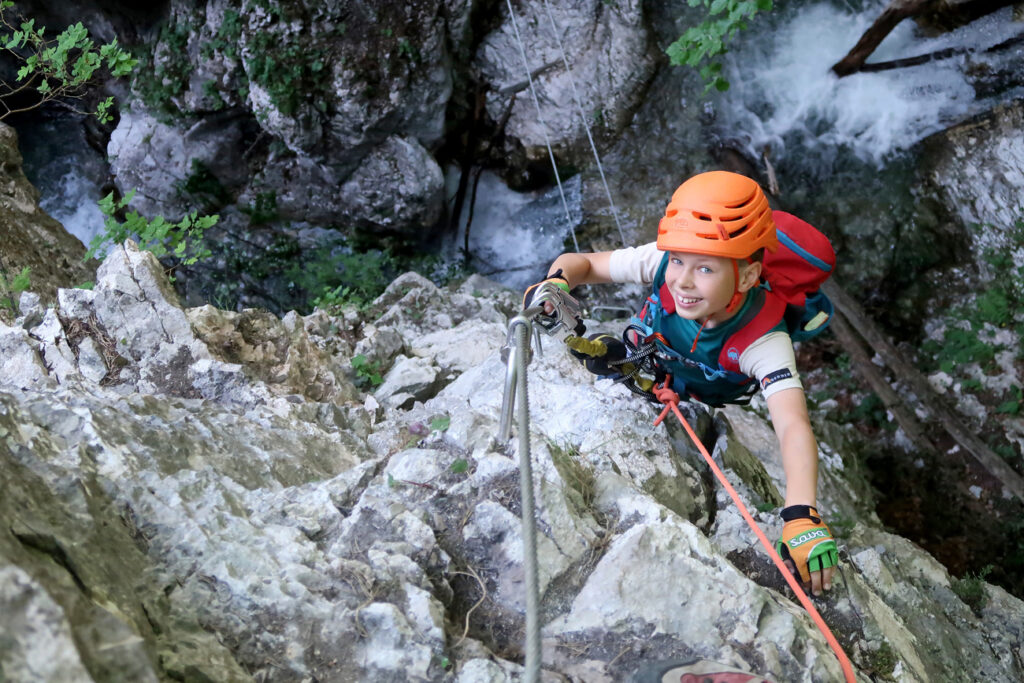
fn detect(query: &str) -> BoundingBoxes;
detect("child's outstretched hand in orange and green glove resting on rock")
[777,505,839,595]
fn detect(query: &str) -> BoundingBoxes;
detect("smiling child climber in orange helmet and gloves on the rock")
[525,171,838,595]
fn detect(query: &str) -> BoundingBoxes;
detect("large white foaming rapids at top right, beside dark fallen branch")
[717,2,1024,164]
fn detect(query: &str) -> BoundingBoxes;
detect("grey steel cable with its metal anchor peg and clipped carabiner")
[500,283,586,683]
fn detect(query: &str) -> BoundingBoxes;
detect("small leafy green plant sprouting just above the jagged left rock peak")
[85,190,220,272]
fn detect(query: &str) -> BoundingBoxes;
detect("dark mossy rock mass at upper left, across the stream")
[108,0,454,232]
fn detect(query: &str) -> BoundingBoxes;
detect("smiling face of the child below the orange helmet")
[665,252,761,327]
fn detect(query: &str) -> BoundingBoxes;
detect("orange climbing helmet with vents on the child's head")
[657,171,778,259]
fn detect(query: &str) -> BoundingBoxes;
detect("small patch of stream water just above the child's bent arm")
[444,171,583,290]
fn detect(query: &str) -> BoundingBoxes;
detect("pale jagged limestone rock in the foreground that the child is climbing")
[0,243,1024,682]
